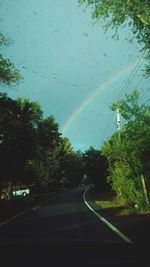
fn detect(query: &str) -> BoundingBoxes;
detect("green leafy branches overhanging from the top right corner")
[78,0,150,74]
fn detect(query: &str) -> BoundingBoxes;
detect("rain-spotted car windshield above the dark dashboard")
[0,0,150,264]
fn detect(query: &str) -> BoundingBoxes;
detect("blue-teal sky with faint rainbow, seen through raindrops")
[0,0,150,151]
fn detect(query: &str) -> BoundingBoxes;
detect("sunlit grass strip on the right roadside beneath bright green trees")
[94,192,150,216]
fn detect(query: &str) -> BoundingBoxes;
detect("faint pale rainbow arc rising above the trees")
[60,59,139,133]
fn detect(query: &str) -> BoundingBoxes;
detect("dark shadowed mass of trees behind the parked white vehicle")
[0,93,83,192]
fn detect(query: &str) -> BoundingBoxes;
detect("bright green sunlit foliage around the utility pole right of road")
[102,92,150,208]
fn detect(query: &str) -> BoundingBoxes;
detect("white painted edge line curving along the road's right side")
[83,188,132,243]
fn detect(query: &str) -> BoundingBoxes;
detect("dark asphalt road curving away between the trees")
[0,188,124,243]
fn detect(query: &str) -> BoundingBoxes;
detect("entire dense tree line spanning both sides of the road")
[0,91,150,208]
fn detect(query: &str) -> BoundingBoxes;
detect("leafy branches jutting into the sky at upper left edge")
[0,32,22,85]
